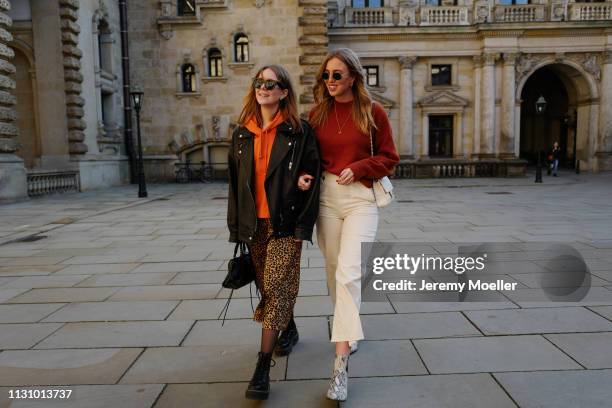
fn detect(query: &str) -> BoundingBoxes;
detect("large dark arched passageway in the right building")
[519,63,598,168]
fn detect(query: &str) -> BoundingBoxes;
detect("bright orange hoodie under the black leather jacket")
[246,112,285,218]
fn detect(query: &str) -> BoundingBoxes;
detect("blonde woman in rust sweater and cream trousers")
[298,48,399,401]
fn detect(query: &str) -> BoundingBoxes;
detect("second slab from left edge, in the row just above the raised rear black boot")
[41,300,177,322]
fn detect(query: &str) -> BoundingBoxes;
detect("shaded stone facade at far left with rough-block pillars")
[0,0,129,200]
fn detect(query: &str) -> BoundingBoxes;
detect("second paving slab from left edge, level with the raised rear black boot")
[36,321,193,349]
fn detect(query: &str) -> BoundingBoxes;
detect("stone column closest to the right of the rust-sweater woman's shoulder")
[398,56,417,158]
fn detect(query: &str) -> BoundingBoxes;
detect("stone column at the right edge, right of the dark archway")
[596,51,612,170]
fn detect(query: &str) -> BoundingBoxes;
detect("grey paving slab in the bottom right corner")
[494,370,612,408]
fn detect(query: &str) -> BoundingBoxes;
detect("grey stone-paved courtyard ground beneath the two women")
[0,167,612,408]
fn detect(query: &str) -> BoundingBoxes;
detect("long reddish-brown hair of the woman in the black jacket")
[238,65,302,132]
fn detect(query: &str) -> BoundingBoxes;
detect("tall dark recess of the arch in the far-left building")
[12,47,40,169]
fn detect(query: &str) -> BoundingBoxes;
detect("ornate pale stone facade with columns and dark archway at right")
[328,0,612,175]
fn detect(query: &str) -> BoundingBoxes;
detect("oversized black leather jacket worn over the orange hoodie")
[227,121,321,244]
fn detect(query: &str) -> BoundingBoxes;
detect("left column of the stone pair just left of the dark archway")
[480,53,497,158]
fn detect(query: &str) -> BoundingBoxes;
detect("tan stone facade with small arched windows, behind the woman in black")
[129,0,328,180]
